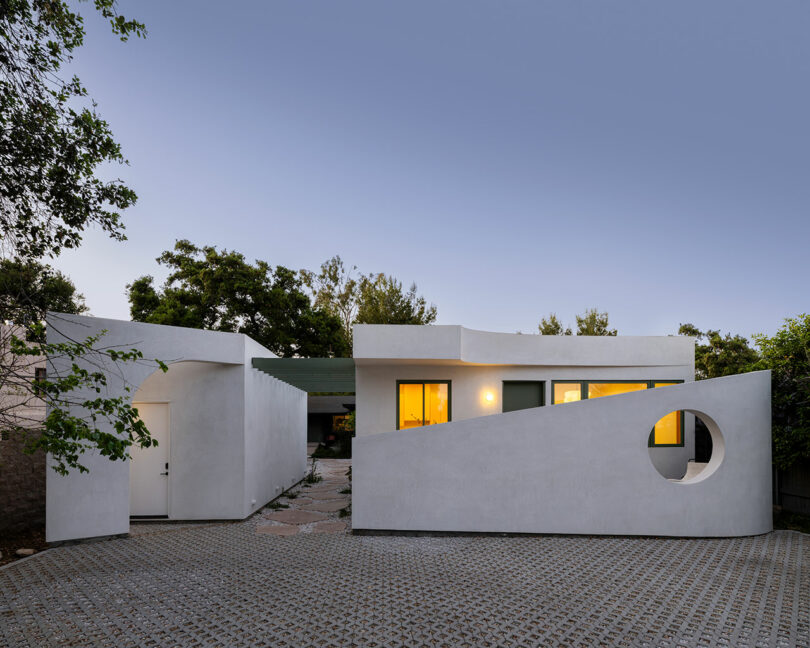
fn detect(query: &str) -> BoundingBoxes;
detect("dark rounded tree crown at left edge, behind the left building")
[0,259,87,330]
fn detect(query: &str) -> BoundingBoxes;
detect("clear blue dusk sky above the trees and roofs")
[56,0,810,335]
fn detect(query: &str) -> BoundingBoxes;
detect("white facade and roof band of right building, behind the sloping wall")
[354,325,695,478]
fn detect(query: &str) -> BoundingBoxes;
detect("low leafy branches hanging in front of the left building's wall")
[0,323,168,475]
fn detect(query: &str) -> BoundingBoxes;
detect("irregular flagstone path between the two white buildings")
[256,459,351,537]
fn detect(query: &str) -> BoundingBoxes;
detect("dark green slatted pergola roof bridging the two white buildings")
[253,358,354,393]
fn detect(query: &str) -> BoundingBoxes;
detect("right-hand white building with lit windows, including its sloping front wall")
[352,325,771,536]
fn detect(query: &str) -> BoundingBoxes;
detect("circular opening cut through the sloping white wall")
[647,410,725,483]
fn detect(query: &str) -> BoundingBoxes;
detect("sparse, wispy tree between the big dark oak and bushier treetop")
[300,256,360,344]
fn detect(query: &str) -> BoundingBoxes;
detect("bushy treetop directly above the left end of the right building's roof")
[356,273,436,324]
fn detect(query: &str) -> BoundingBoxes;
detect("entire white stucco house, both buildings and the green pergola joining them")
[46,314,771,541]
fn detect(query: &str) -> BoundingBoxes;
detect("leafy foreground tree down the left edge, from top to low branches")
[0,0,162,474]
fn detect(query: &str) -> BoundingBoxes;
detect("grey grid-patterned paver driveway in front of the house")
[0,462,810,648]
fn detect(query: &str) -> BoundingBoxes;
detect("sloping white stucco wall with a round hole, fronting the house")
[352,372,771,537]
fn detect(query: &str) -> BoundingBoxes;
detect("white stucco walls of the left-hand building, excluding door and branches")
[46,313,306,542]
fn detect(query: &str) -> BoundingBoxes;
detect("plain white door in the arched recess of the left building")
[129,403,169,517]
